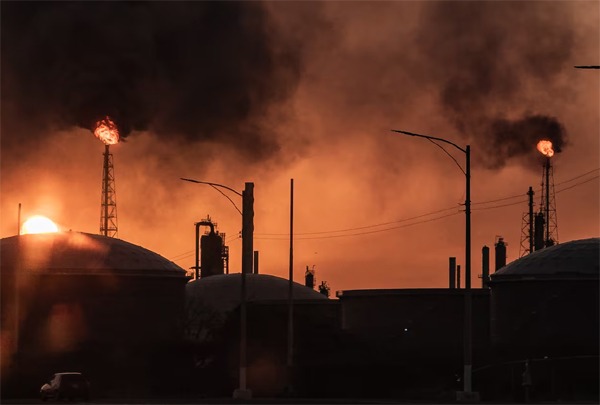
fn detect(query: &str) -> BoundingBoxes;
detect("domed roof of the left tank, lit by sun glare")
[0,231,185,277]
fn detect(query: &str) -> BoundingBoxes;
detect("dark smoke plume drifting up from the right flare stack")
[417,1,574,168]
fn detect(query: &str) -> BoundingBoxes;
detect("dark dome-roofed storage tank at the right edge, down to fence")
[490,238,600,358]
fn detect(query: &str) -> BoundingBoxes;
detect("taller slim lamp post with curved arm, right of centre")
[392,129,473,396]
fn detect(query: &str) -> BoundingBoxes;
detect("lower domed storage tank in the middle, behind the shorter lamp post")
[186,273,330,396]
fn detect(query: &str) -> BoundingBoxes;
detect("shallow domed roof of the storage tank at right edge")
[490,238,600,281]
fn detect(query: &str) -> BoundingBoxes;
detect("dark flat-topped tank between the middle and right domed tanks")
[338,288,490,399]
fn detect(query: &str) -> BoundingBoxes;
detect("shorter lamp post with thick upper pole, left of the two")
[181,178,254,399]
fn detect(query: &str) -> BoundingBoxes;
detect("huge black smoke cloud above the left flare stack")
[1,2,301,158]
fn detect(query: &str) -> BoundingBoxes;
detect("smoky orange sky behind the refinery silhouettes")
[0,1,600,292]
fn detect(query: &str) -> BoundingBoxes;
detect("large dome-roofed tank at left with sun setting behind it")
[0,232,188,393]
